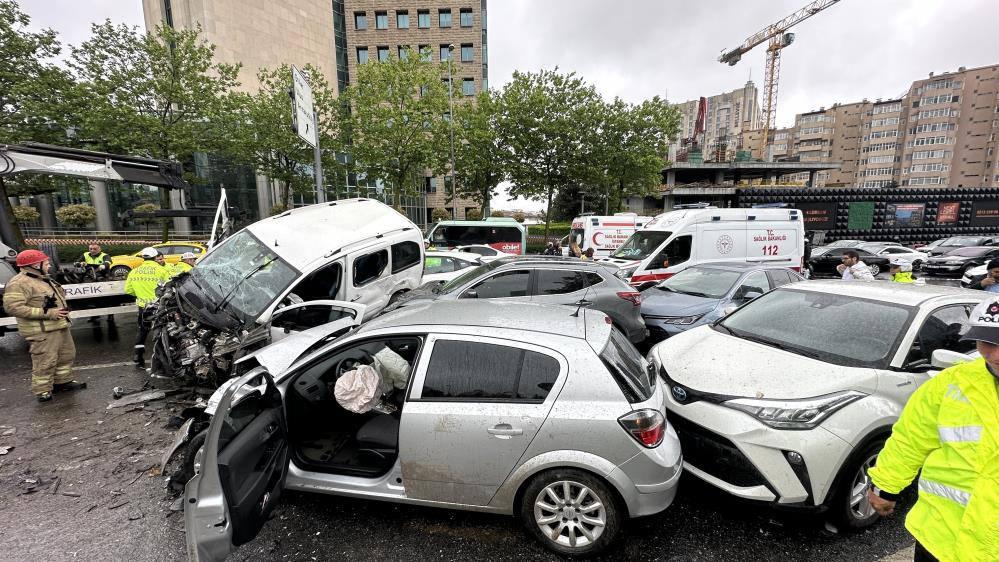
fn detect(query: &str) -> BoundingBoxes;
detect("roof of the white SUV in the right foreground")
[780,280,988,306]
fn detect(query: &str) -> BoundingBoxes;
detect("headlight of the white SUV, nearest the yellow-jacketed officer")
[722,390,867,429]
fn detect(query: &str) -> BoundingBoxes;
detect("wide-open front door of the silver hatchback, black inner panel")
[184,369,288,561]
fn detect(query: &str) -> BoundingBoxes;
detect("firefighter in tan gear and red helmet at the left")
[3,250,87,402]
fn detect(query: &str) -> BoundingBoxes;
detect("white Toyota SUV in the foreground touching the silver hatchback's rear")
[649,281,986,529]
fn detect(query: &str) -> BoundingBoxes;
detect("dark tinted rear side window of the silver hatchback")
[420,340,559,402]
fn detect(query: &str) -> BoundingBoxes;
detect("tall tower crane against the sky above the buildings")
[718,0,840,151]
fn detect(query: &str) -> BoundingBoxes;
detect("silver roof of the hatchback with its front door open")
[358,299,586,339]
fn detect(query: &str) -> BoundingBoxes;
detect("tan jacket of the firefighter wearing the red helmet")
[3,269,69,336]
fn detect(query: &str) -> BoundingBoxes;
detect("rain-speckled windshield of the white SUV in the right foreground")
[715,288,914,369]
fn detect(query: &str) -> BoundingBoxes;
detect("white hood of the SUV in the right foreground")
[652,326,877,399]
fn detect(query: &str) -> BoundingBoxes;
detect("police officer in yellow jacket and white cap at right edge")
[867,298,999,561]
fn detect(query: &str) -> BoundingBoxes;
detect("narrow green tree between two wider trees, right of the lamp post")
[455,90,506,213]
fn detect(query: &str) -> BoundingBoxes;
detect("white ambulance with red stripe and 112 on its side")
[600,207,805,287]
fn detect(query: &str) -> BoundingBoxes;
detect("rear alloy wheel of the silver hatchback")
[520,469,623,556]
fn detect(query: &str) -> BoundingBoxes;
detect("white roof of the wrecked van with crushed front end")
[246,198,422,269]
